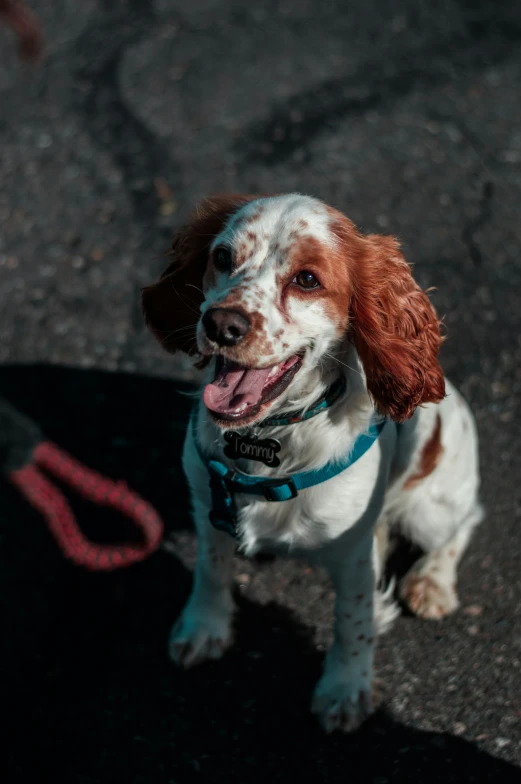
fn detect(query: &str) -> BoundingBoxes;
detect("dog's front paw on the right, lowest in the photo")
[311,673,380,733]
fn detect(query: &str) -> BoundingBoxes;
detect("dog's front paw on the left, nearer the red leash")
[168,604,233,669]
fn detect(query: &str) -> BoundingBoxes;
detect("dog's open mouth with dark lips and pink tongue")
[203,354,302,425]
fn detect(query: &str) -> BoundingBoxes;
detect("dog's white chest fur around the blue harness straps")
[184,392,395,560]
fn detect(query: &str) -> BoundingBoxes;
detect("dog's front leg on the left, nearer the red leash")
[169,500,235,668]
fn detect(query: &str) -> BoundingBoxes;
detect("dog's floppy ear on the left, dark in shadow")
[141,194,257,355]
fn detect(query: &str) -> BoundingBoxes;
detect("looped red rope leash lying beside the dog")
[8,441,163,571]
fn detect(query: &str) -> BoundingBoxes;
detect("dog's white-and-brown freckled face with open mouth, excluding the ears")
[197,196,349,424]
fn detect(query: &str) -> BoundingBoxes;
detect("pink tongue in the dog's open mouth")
[203,362,271,414]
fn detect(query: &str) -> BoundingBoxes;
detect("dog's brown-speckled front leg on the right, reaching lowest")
[311,532,375,732]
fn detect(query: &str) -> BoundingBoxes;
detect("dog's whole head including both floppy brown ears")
[143,194,444,428]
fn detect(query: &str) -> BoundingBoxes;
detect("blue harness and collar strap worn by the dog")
[191,382,386,537]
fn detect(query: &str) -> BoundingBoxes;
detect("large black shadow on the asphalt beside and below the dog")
[0,366,519,784]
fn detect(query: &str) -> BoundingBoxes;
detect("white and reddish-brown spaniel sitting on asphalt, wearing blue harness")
[142,194,483,732]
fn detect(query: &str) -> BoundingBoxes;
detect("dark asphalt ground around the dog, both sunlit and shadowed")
[0,0,521,784]
